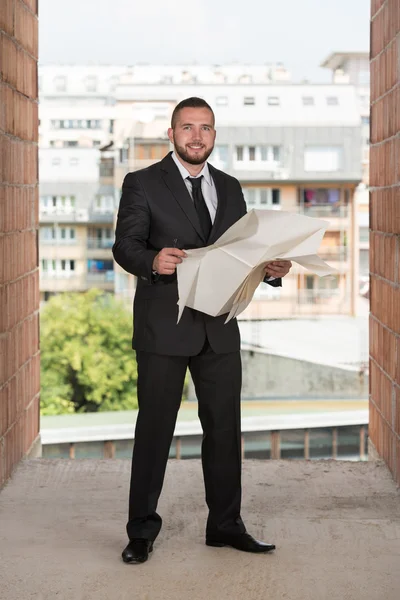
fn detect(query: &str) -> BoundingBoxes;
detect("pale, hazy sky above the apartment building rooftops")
[39,0,370,83]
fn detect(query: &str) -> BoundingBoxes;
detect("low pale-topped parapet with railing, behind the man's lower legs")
[42,410,368,460]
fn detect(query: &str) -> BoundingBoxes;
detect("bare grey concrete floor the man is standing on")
[0,459,400,600]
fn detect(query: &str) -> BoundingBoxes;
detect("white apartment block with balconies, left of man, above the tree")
[39,65,125,300]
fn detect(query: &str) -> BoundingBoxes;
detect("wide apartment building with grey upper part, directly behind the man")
[114,78,361,318]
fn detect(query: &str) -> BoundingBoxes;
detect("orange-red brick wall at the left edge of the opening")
[0,0,39,486]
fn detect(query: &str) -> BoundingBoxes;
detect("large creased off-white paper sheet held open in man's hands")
[177,209,336,323]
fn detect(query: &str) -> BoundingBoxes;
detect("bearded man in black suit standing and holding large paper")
[113,98,291,563]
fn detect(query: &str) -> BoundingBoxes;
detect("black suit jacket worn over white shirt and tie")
[113,153,281,356]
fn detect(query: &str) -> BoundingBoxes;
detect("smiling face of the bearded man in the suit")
[168,108,216,165]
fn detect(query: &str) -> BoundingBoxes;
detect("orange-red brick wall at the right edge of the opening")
[369,0,400,484]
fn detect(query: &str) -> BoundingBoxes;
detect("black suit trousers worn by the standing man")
[127,341,245,541]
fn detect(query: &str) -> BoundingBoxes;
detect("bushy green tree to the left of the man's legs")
[40,289,137,415]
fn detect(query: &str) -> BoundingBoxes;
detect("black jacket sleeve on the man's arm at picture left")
[112,173,157,282]
